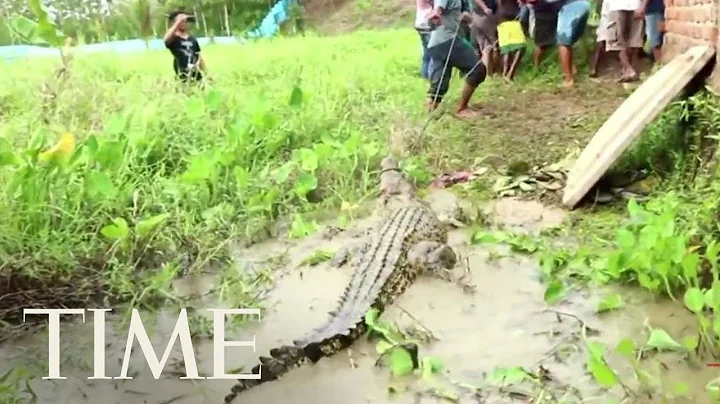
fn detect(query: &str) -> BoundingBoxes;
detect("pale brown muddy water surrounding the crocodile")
[0,197,715,404]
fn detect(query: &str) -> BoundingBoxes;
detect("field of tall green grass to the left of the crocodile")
[0,30,438,321]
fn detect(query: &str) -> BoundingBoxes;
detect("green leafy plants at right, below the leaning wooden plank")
[473,91,720,401]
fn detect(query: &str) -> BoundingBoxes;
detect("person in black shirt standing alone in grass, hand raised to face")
[163,11,207,82]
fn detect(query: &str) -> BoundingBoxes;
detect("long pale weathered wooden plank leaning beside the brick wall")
[563,46,715,208]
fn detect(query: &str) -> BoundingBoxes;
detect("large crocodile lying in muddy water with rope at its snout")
[224,158,457,404]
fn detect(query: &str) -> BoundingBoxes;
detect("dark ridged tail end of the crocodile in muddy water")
[225,318,367,404]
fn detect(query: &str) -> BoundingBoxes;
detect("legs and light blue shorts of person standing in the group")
[557,0,591,87]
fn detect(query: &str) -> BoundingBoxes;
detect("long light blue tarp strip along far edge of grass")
[0,0,294,60]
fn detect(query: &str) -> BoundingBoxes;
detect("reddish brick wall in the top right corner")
[663,0,720,61]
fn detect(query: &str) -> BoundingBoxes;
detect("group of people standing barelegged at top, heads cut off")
[415,0,664,117]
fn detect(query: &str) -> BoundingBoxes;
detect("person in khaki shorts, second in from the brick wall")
[605,0,645,83]
